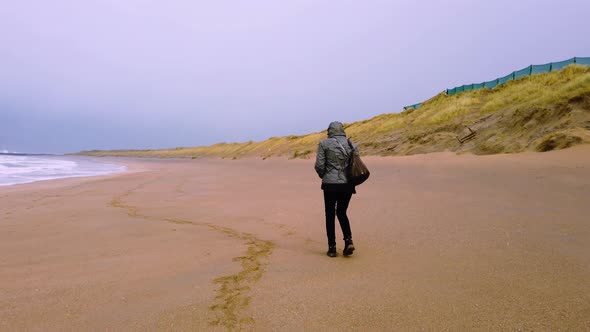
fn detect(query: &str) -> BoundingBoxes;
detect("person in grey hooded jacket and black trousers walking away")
[315,121,358,257]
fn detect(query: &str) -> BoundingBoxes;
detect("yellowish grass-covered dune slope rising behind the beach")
[81,65,590,159]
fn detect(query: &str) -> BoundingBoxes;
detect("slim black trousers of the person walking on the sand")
[324,190,352,246]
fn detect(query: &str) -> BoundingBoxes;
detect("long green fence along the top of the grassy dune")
[404,57,590,111]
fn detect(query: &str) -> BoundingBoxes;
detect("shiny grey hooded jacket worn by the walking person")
[315,122,359,189]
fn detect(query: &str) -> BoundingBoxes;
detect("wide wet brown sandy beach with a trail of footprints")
[0,146,590,331]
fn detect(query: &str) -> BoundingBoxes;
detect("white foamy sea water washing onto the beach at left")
[0,153,126,186]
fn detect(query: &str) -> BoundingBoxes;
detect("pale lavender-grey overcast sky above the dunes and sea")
[0,0,590,153]
